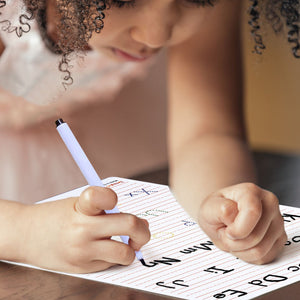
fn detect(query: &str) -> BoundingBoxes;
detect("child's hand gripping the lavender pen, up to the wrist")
[23,187,150,273]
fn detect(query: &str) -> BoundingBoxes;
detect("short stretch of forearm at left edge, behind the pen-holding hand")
[0,200,30,261]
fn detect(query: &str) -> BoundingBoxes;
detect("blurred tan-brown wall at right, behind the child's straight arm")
[243,1,300,153]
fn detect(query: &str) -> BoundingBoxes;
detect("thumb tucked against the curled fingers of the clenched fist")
[201,196,238,226]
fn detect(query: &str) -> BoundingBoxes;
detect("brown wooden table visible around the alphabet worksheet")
[0,153,300,300]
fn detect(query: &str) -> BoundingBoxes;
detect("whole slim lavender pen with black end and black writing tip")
[55,119,145,264]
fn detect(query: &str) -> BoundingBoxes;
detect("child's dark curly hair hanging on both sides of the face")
[0,0,300,88]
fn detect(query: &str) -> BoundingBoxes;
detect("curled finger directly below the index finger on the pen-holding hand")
[89,239,135,266]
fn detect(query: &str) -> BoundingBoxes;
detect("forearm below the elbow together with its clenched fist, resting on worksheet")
[171,134,287,264]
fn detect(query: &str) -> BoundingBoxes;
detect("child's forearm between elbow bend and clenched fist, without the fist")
[170,135,256,219]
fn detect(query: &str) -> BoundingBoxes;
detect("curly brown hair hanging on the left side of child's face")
[0,0,109,89]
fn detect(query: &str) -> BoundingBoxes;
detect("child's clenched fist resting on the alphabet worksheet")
[199,183,287,264]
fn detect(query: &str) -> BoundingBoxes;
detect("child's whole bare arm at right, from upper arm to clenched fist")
[169,0,286,263]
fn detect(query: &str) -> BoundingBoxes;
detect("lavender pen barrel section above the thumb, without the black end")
[56,123,104,187]
